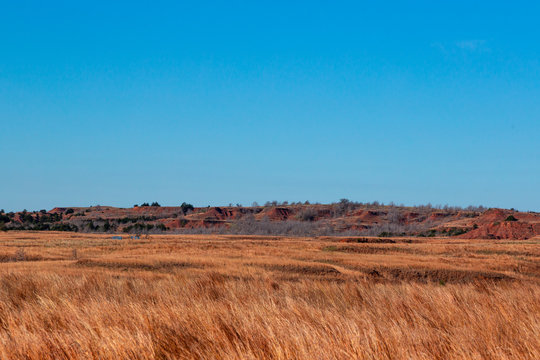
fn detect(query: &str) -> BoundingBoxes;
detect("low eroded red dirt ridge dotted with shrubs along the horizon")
[5,203,540,239]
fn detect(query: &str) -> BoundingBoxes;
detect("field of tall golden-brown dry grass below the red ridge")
[0,232,540,359]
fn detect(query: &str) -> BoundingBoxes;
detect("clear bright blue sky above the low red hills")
[0,1,540,210]
